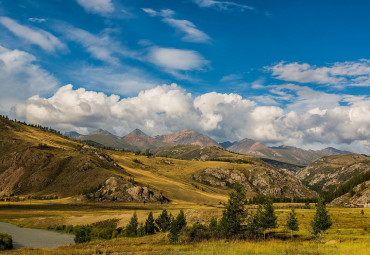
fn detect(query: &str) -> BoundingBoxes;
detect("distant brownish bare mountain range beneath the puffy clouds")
[65,129,351,167]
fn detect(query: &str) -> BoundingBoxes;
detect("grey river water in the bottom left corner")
[0,222,75,249]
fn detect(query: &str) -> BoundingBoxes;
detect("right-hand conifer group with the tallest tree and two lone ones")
[175,184,332,241]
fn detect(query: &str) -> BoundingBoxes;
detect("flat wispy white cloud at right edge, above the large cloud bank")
[266,59,370,87]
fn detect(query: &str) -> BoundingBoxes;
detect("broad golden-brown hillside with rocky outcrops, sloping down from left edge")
[0,118,315,204]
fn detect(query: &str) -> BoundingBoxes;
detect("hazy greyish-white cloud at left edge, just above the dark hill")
[0,46,58,112]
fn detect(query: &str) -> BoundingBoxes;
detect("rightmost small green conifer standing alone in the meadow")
[311,199,332,238]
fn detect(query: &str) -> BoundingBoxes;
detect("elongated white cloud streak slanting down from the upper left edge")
[0,17,66,52]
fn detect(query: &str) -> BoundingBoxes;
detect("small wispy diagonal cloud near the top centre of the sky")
[142,8,211,42]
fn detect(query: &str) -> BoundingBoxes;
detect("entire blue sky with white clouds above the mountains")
[0,0,370,153]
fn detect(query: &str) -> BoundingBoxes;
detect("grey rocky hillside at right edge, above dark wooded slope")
[297,154,370,192]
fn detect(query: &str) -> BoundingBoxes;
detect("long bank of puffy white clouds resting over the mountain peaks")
[15,84,370,152]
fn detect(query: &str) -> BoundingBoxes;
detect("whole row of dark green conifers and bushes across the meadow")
[54,184,332,243]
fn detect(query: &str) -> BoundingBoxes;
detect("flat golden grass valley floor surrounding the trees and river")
[0,202,370,255]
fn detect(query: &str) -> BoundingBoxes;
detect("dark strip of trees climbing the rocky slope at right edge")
[325,171,370,203]
